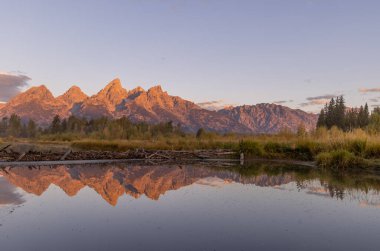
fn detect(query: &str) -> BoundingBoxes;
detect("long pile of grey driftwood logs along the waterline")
[0,149,239,162]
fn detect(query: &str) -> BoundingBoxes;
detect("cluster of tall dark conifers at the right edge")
[317,96,380,132]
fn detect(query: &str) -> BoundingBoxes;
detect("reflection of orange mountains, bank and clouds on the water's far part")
[0,163,380,207]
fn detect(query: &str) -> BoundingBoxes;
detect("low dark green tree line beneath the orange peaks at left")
[0,114,184,139]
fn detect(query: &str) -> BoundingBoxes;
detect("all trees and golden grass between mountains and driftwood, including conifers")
[0,97,380,169]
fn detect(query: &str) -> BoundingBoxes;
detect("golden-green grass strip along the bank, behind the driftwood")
[0,128,380,169]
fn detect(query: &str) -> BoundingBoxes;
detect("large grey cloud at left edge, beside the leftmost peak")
[0,72,31,102]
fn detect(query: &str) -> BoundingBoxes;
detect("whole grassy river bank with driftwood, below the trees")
[0,127,380,169]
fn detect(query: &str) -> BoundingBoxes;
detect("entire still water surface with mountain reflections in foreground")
[0,163,380,251]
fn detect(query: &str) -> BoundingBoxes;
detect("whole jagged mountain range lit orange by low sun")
[0,79,317,133]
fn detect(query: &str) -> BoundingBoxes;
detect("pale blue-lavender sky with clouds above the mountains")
[0,0,380,112]
